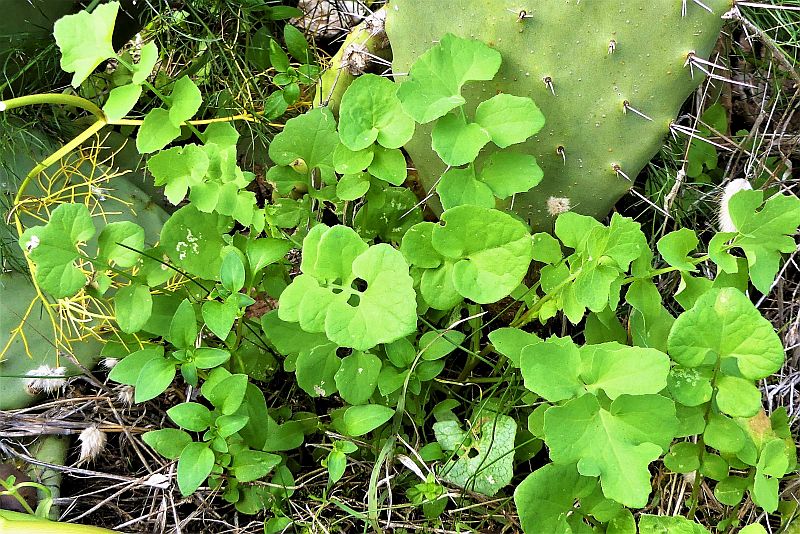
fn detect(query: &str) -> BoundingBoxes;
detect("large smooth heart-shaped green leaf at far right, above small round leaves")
[668,288,784,380]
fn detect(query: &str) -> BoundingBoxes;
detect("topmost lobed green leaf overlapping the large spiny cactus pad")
[397,33,502,124]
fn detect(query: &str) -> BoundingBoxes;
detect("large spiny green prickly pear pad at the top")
[386,0,732,229]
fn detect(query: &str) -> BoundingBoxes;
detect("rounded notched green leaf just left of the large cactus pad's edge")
[339,74,414,150]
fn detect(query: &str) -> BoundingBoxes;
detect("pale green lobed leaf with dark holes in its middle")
[278,225,417,350]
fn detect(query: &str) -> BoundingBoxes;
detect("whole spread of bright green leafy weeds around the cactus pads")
[20,3,800,534]
